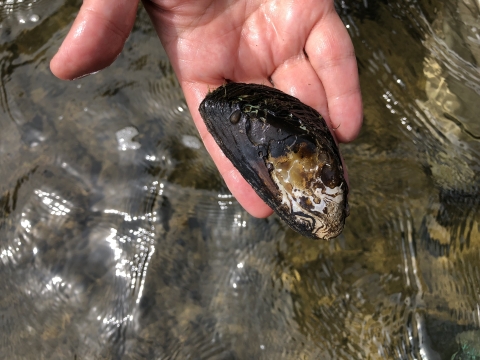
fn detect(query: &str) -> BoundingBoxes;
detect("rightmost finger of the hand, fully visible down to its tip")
[305,9,363,142]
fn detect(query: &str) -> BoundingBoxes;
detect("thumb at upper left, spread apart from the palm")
[50,0,138,80]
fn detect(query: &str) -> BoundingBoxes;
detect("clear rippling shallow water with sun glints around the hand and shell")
[0,0,480,360]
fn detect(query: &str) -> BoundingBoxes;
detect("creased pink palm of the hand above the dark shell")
[150,1,316,82]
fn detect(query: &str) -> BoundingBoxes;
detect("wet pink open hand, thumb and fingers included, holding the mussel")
[50,0,363,217]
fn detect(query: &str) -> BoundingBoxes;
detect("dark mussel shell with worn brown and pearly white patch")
[199,83,348,239]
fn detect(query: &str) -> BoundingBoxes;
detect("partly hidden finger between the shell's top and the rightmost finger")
[271,54,329,129]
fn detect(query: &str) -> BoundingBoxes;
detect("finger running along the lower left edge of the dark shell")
[182,82,273,218]
